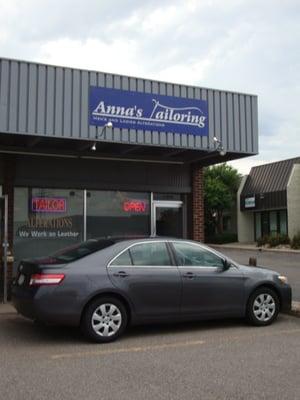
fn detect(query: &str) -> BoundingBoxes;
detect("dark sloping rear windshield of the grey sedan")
[51,239,115,263]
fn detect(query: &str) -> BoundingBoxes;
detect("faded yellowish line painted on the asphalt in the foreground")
[51,340,205,360]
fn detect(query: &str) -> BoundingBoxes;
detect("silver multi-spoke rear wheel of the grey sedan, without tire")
[92,303,122,337]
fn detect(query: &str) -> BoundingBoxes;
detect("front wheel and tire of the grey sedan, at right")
[247,287,280,326]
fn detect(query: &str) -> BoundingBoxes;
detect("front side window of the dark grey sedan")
[173,242,223,268]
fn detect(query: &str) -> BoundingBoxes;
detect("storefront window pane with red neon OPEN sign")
[87,191,150,239]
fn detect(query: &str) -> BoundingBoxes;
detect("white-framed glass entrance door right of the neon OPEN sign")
[151,201,184,238]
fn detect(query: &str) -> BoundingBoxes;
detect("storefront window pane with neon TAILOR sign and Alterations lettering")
[14,188,83,262]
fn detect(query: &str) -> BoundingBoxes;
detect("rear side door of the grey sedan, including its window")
[108,241,181,319]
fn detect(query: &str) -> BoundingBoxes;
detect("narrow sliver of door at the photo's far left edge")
[0,196,8,303]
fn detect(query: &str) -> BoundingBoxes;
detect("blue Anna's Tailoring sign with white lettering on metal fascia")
[89,86,208,136]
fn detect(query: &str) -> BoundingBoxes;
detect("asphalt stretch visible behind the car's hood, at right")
[211,247,300,301]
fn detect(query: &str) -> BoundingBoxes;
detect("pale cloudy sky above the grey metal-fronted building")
[0,0,300,174]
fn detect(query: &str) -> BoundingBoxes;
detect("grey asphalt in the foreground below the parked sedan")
[0,313,300,400]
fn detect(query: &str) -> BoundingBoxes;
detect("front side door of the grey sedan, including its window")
[171,241,245,316]
